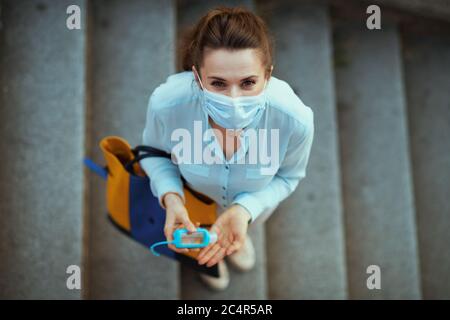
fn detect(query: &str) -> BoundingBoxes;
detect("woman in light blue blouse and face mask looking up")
[140,7,314,290]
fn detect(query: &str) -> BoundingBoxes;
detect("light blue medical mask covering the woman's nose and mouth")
[197,70,267,129]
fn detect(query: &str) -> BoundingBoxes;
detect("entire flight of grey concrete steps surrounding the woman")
[0,0,450,299]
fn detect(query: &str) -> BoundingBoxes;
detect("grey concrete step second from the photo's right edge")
[334,13,421,299]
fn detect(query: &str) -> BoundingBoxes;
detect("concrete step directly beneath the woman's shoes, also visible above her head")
[177,0,267,299]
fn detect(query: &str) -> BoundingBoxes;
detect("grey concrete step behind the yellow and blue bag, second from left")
[85,0,179,299]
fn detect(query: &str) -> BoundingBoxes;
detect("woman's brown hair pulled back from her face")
[181,7,273,77]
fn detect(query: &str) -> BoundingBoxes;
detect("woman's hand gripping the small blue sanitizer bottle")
[163,192,197,253]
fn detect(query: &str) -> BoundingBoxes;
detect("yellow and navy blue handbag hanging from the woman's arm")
[84,136,219,277]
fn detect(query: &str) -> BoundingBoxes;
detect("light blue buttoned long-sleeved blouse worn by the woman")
[140,71,314,222]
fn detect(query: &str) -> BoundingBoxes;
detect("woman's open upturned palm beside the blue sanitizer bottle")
[197,204,251,267]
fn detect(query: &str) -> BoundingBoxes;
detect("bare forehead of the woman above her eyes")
[202,49,264,80]
